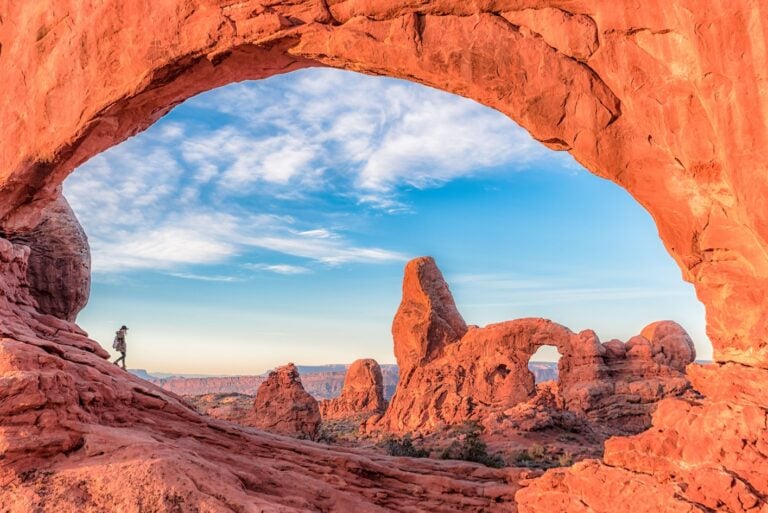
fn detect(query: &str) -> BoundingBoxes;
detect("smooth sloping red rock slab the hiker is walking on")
[0,238,519,513]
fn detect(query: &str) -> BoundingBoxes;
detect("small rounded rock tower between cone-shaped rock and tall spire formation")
[320,358,387,419]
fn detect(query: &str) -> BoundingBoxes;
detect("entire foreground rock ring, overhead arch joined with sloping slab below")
[0,0,768,513]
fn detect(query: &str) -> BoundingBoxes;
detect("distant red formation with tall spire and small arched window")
[379,257,696,432]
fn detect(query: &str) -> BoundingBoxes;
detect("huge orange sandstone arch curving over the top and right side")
[0,0,768,511]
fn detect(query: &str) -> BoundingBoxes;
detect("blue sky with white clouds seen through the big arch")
[64,69,711,374]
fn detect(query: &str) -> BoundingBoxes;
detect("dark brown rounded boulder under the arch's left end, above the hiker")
[10,192,91,321]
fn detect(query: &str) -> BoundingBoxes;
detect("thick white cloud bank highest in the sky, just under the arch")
[201,70,571,200]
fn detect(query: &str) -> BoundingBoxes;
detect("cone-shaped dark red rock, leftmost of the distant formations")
[243,363,320,440]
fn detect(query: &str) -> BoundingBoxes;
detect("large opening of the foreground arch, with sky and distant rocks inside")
[9,70,706,500]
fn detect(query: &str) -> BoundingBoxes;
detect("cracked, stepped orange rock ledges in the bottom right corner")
[517,364,768,513]
